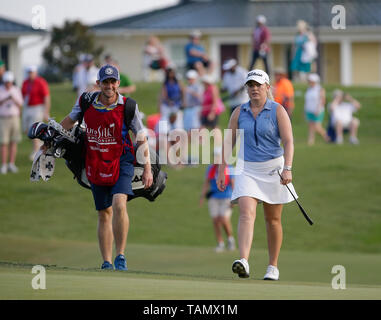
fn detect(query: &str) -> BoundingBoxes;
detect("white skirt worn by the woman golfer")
[231,156,298,204]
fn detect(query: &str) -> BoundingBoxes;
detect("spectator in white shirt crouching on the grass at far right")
[330,90,361,144]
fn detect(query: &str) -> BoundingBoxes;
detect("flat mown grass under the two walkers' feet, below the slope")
[0,236,381,300]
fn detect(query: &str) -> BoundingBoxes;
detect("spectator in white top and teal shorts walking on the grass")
[304,73,330,146]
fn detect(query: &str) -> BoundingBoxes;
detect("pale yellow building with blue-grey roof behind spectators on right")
[92,0,381,86]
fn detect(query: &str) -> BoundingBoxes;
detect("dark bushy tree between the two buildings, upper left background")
[43,21,103,80]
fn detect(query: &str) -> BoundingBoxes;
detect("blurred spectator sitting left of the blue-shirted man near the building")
[143,36,168,81]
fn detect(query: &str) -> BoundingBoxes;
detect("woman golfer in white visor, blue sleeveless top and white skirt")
[217,69,295,280]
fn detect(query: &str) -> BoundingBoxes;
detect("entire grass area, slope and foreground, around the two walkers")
[0,83,381,299]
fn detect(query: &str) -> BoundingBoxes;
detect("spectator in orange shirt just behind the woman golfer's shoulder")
[273,67,295,119]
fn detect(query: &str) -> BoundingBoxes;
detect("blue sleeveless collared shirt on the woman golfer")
[238,99,284,162]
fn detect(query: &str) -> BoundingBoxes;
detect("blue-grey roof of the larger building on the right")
[92,0,381,31]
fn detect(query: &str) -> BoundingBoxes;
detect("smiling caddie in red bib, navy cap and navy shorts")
[61,65,153,270]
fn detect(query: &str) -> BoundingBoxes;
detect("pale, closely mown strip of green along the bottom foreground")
[0,268,381,305]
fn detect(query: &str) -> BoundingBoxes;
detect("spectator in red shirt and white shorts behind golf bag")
[21,66,50,161]
